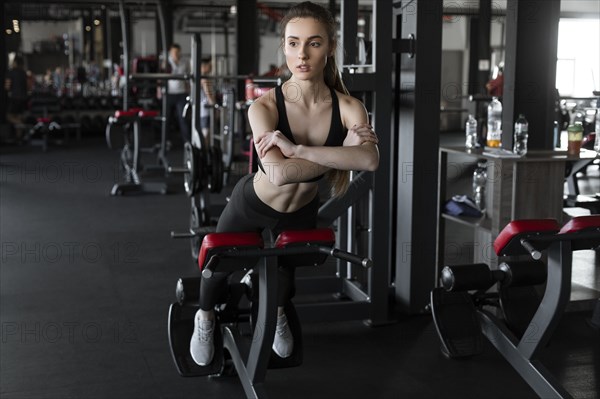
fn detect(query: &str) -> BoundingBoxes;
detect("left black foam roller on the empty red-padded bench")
[441,263,497,292]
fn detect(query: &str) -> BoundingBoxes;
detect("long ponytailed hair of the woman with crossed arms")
[281,1,350,197]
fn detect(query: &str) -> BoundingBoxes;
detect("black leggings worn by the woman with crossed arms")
[200,174,319,311]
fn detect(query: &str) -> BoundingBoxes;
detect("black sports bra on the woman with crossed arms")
[256,86,348,183]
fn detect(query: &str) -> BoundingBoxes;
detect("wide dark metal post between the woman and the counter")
[396,0,442,313]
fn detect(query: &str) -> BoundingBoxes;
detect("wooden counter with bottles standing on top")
[437,147,598,275]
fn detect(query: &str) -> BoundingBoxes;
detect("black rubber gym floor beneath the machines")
[0,140,600,399]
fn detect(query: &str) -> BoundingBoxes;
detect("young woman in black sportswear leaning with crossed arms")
[190,2,379,366]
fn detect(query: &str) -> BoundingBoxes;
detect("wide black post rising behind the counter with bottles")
[502,0,560,150]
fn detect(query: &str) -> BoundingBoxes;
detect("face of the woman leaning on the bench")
[283,18,333,80]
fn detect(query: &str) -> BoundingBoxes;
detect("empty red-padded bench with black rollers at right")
[431,215,600,398]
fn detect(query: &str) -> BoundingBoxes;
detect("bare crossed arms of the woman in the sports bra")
[248,95,379,186]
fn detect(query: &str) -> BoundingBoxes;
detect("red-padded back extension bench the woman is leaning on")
[168,228,372,398]
